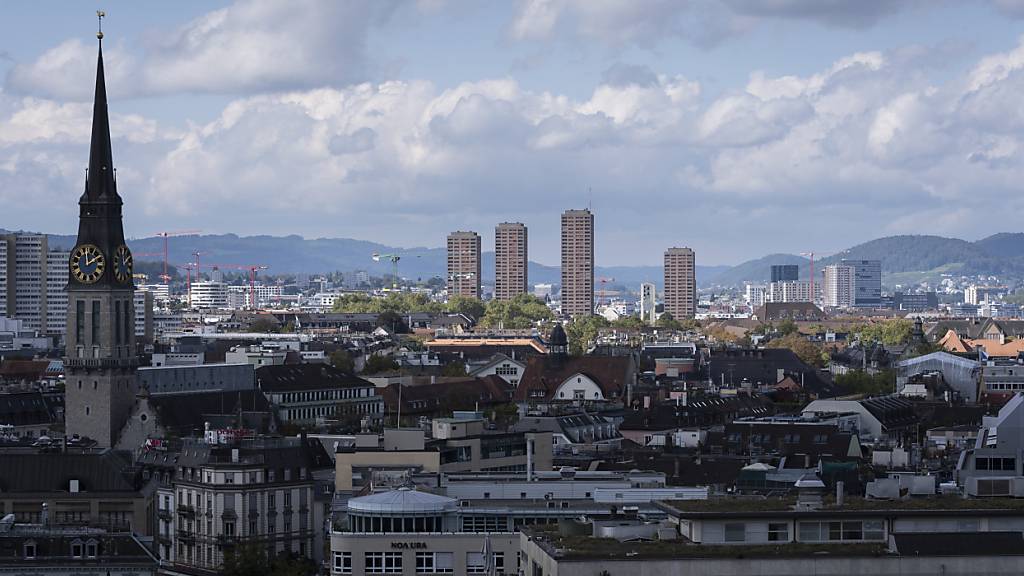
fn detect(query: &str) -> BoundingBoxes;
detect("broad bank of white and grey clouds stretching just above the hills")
[9,24,1024,263]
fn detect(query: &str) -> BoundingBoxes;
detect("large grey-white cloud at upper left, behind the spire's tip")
[6,0,399,100]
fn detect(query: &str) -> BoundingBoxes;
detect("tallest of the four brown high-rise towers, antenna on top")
[561,210,594,318]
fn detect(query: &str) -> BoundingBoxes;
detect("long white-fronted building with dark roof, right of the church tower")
[256,363,384,424]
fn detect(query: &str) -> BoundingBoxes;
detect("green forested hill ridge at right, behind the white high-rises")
[705,233,1024,286]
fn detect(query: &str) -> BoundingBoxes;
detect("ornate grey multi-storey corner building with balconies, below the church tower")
[157,439,330,575]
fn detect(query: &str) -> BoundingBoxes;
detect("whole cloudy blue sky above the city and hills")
[0,0,1024,265]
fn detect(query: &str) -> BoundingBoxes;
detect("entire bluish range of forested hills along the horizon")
[0,231,1024,289]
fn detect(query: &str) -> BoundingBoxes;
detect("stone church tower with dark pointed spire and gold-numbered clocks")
[65,17,138,447]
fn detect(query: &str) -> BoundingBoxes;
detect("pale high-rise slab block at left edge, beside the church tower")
[0,234,71,336]
